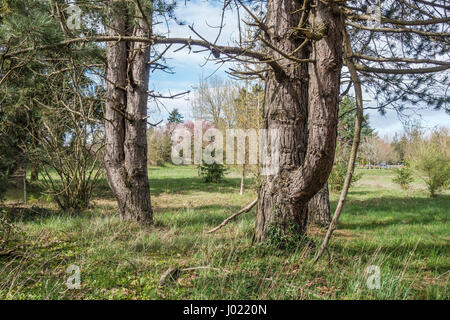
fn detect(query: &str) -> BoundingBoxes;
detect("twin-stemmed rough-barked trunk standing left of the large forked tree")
[105,1,153,223]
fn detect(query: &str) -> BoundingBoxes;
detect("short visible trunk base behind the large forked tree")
[308,182,331,227]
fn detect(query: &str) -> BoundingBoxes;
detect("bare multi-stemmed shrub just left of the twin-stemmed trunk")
[27,96,103,212]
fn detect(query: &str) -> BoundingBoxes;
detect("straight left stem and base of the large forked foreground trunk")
[254,0,309,242]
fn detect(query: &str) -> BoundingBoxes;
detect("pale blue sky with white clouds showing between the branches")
[149,0,450,138]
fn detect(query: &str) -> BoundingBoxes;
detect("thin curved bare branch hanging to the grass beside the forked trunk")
[314,29,364,263]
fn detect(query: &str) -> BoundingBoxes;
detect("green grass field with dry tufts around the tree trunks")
[0,166,450,299]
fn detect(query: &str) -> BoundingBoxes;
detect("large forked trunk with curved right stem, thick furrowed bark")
[254,0,343,242]
